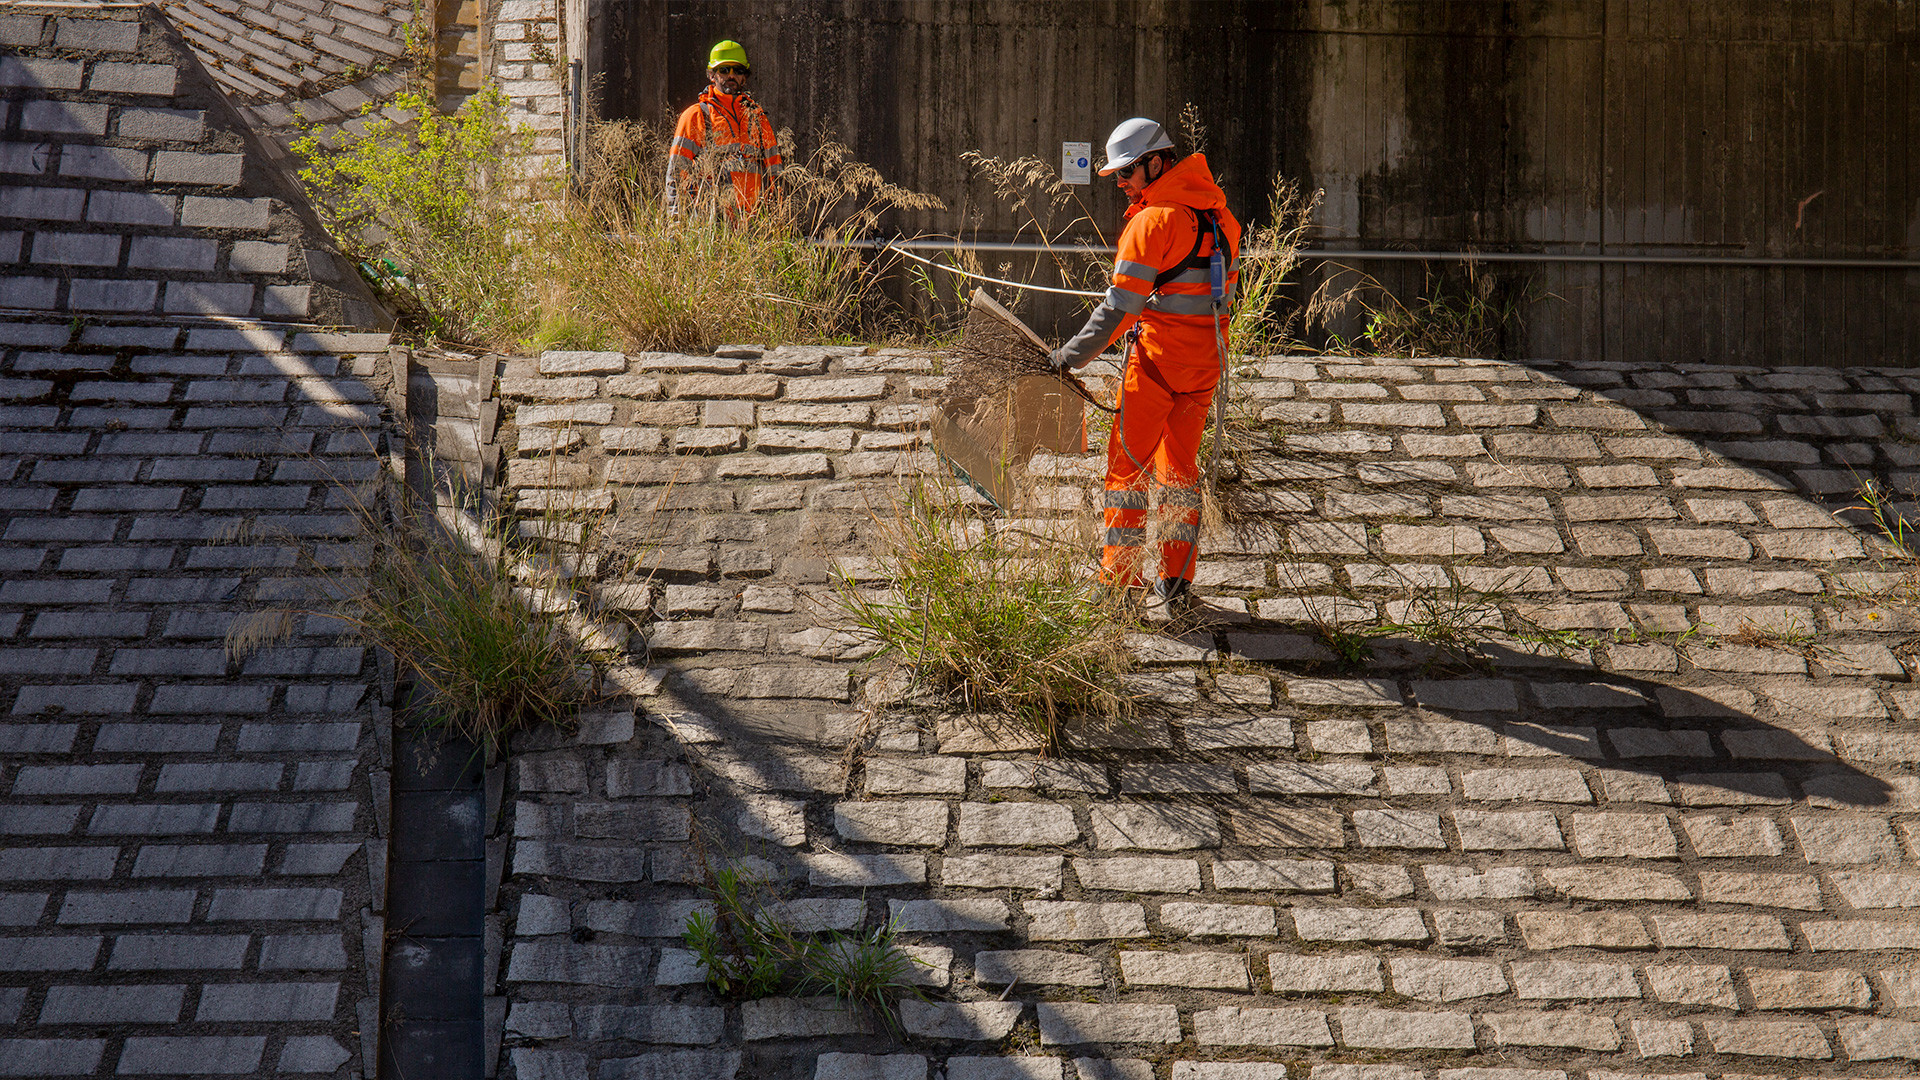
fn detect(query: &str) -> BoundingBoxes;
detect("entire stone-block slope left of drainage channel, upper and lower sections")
[0,4,405,1076]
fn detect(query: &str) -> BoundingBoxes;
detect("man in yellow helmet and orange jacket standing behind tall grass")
[666,40,781,219]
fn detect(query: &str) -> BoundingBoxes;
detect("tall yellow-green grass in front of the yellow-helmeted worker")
[296,92,939,352]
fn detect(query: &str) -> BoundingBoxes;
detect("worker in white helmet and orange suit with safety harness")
[1052,119,1240,615]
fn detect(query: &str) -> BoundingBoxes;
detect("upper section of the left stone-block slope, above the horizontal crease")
[0,4,392,325]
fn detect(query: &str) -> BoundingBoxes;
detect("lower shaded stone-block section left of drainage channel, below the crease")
[0,313,386,1076]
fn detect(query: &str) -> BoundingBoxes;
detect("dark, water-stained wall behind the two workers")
[586,0,1920,365]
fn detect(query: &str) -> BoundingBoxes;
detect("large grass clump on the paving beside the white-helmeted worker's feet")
[835,484,1135,748]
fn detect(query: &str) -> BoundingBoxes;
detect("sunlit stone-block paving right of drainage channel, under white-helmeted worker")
[490,346,1920,1080]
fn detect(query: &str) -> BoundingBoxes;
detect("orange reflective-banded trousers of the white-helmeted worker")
[1100,340,1219,588]
